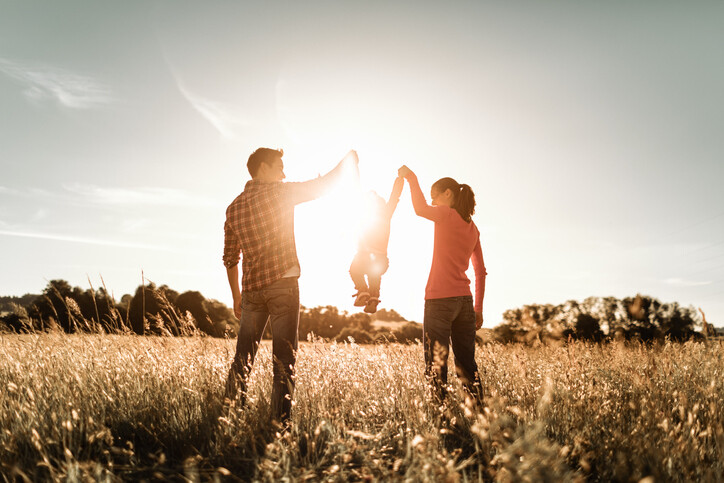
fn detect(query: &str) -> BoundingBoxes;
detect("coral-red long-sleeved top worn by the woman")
[409,174,487,312]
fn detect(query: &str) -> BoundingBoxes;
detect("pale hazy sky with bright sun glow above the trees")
[0,0,724,327]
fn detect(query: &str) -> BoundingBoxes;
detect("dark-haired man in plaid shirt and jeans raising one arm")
[224,148,359,425]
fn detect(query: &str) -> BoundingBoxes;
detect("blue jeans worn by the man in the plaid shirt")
[226,278,299,423]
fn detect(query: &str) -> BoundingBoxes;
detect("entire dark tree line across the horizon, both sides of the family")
[0,280,707,344]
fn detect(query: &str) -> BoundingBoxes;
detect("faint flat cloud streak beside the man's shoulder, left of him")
[63,183,218,207]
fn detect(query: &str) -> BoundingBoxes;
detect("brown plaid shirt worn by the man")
[224,178,329,290]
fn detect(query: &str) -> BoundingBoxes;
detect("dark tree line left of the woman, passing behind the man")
[0,280,422,343]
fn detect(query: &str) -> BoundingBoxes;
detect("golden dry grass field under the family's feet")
[0,334,724,481]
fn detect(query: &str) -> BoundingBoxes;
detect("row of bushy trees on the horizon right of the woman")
[494,294,706,342]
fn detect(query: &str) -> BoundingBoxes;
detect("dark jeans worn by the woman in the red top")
[422,295,482,402]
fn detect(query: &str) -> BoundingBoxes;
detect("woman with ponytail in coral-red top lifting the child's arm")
[398,166,487,401]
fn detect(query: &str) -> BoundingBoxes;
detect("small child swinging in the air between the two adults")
[349,177,405,314]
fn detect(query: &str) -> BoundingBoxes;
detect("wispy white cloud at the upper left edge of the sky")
[0,58,115,109]
